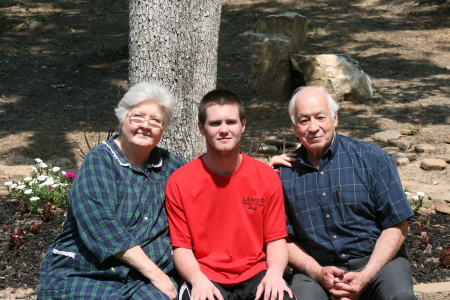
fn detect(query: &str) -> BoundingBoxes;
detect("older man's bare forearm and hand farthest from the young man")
[333,220,409,299]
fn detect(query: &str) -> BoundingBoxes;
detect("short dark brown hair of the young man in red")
[198,89,245,124]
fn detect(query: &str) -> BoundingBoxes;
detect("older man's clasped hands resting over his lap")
[330,272,370,300]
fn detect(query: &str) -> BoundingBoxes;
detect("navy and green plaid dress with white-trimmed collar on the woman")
[38,139,185,300]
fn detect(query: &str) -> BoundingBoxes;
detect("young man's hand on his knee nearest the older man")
[255,270,294,300]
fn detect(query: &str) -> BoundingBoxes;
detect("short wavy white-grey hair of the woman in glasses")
[114,80,175,134]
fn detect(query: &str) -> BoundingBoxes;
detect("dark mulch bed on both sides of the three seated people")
[0,196,450,290]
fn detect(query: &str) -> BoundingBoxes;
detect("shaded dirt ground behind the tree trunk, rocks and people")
[0,0,450,298]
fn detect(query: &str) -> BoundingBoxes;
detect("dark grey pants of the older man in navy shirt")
[291,256,417,300]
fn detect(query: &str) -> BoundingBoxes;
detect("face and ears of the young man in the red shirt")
[198,105,245,155]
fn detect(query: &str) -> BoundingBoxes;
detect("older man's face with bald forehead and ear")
[293,87,338,157]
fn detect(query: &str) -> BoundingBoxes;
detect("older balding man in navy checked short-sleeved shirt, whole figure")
[269,87,416,300]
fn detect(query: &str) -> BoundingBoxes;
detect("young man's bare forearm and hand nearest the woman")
[173,248,223,300]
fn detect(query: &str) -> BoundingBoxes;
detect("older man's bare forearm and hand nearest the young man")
[288,236,345,291]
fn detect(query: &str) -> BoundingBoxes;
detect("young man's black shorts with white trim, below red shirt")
[178,271,296,300]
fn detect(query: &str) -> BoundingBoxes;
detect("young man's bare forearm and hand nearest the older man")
[255,239,294,300]
